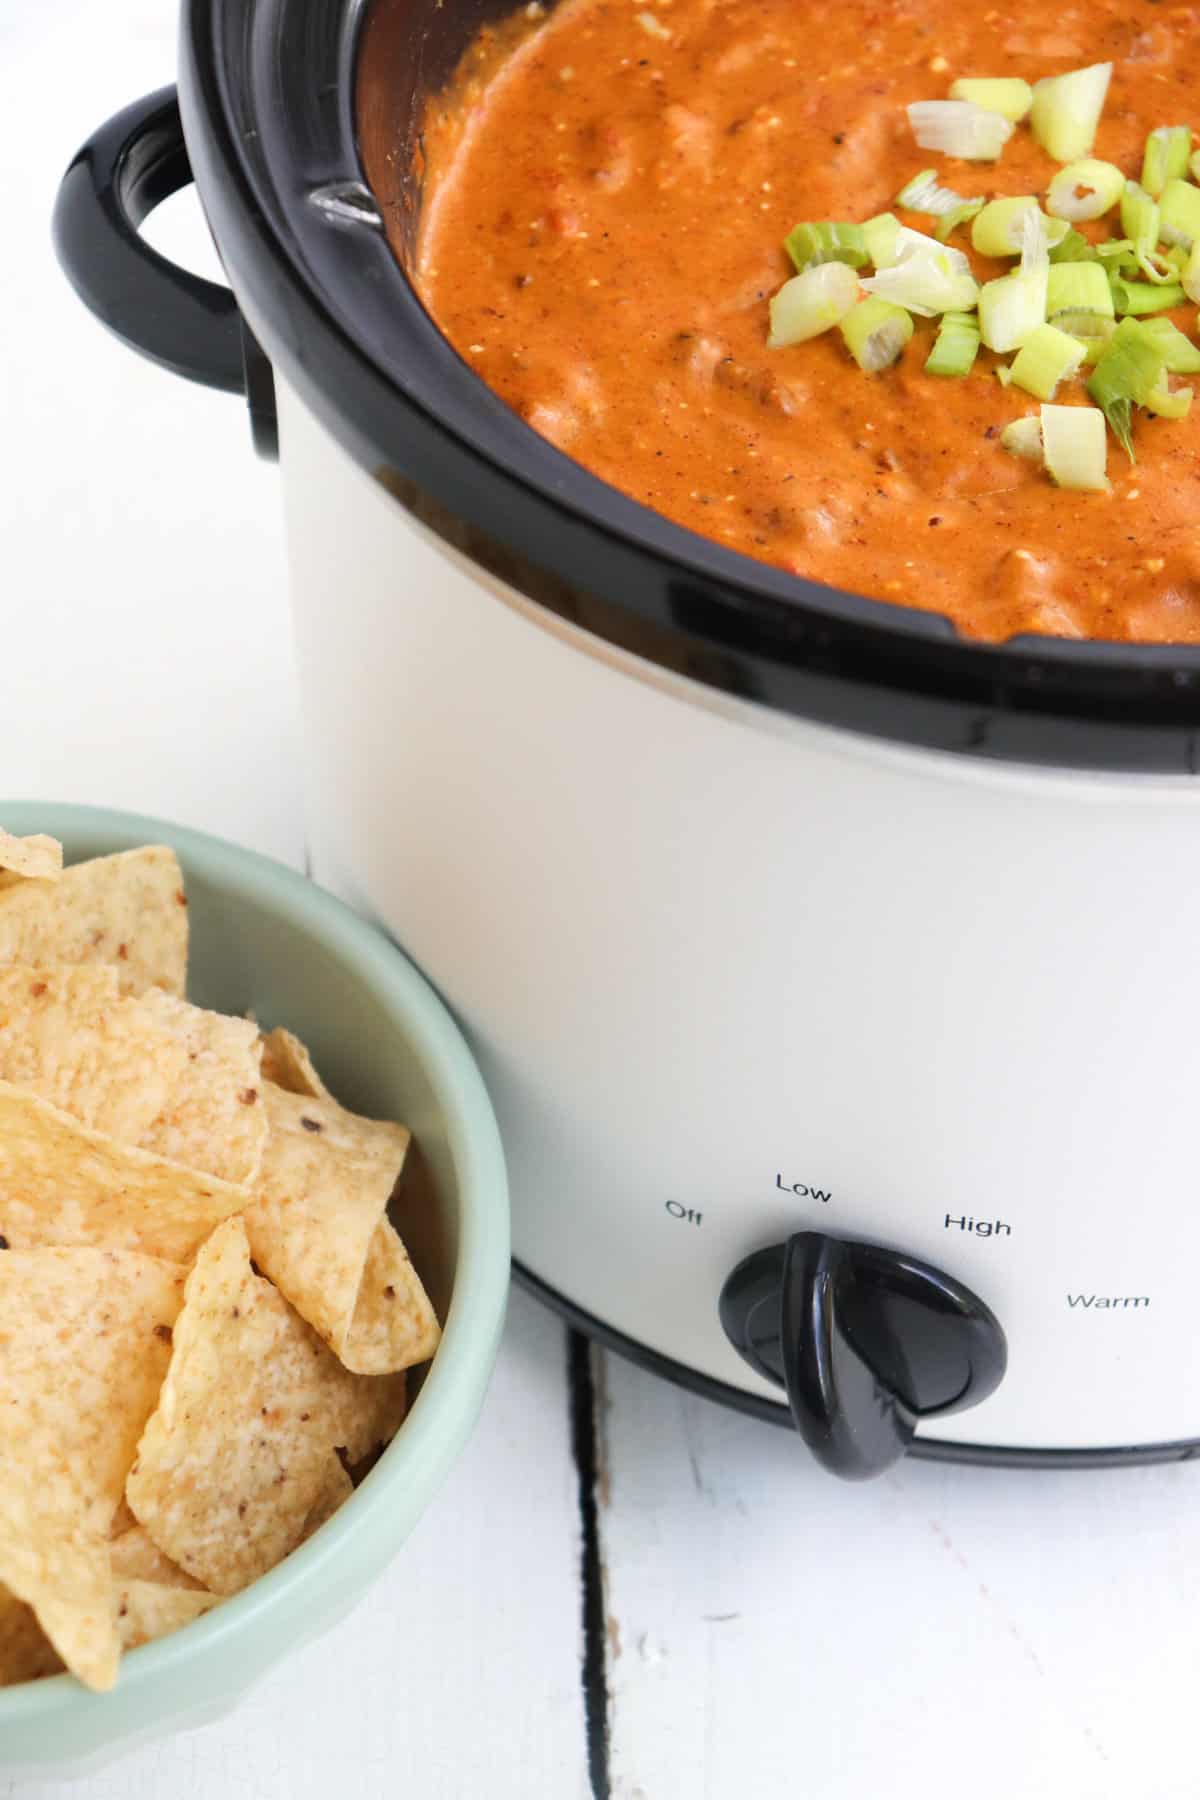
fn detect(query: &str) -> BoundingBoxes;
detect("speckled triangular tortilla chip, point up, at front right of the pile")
[126,1219,405,1595]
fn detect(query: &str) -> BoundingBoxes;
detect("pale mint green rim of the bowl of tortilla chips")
[0,801,509,1728]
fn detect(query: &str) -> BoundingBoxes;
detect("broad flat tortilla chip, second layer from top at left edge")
[0,963,266,1181]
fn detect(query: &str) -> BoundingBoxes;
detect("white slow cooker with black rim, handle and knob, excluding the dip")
[56,0,1200,1476]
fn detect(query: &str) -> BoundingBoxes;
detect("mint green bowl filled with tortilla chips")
[0,803,509,1775]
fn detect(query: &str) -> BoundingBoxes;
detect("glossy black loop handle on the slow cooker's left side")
[54,88,277,455]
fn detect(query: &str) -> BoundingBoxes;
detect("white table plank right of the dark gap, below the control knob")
[601,1359,1200,1800]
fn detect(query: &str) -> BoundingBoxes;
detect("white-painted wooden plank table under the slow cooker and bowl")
[0,0,1200,1800]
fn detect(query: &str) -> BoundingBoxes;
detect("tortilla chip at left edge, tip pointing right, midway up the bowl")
[0,1082,248,1264]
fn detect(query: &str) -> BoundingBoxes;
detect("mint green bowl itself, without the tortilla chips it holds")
[0,803,509,1777]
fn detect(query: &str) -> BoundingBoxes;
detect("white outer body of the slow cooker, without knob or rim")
[279,383,1200,1451]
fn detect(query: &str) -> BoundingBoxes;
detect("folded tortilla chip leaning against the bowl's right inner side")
[245,1082,439,1375]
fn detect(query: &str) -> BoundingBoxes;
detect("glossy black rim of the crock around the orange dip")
[180,0,1200,774]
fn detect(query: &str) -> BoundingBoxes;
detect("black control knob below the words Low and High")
[720,1231,1007,1481]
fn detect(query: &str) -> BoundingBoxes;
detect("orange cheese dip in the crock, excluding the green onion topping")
[417,0,1200,643]
